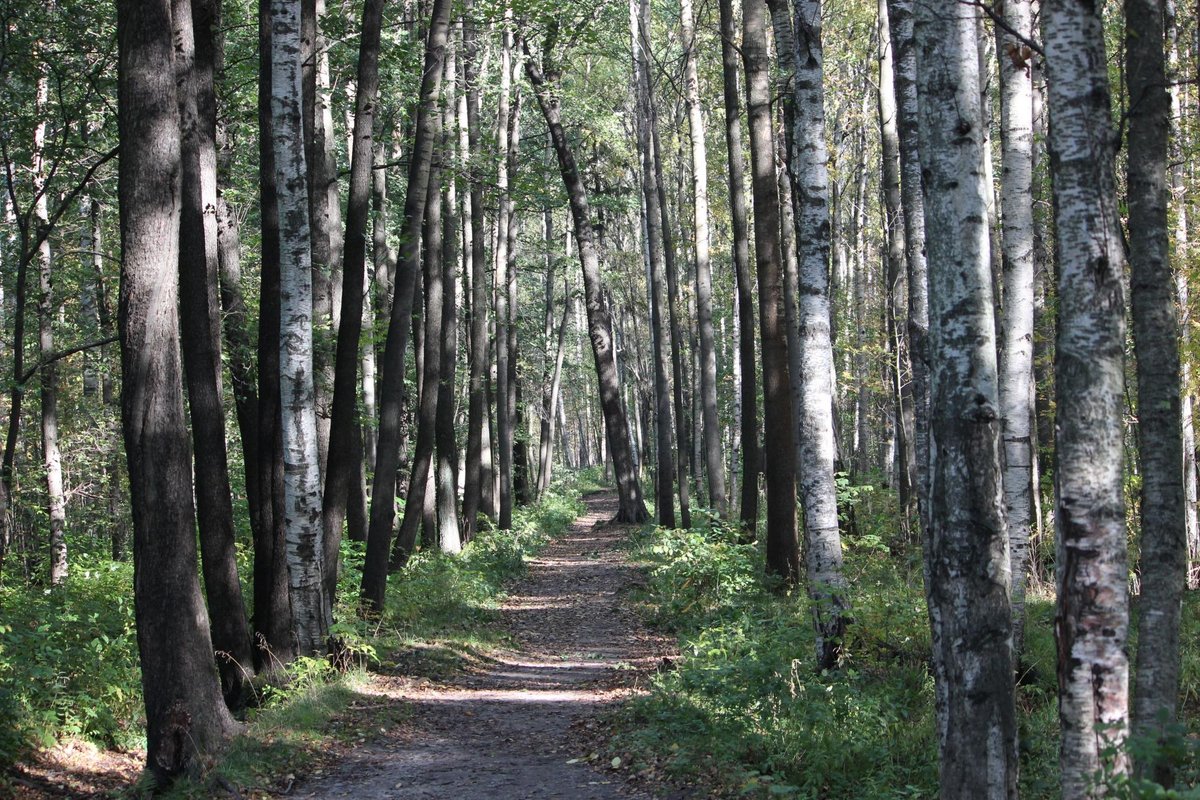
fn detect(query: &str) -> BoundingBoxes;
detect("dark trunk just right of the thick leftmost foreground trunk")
[172,0,253,705]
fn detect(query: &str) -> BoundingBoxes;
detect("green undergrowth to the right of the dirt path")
[614,489,1200,800]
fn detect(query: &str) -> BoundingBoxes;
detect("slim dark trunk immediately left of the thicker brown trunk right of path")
[720,0,761,537]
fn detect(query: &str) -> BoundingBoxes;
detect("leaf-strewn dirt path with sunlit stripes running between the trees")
[294,493,686,800]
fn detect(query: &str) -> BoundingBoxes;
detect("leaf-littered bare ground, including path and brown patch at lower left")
[9,492,695,800]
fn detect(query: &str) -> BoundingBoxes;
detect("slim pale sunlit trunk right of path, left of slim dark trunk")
[679,0,728,517]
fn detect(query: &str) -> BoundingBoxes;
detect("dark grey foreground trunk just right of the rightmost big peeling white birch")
[1124,0,1188,786]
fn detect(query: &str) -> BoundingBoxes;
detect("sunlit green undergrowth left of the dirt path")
[0,473,595,796]
